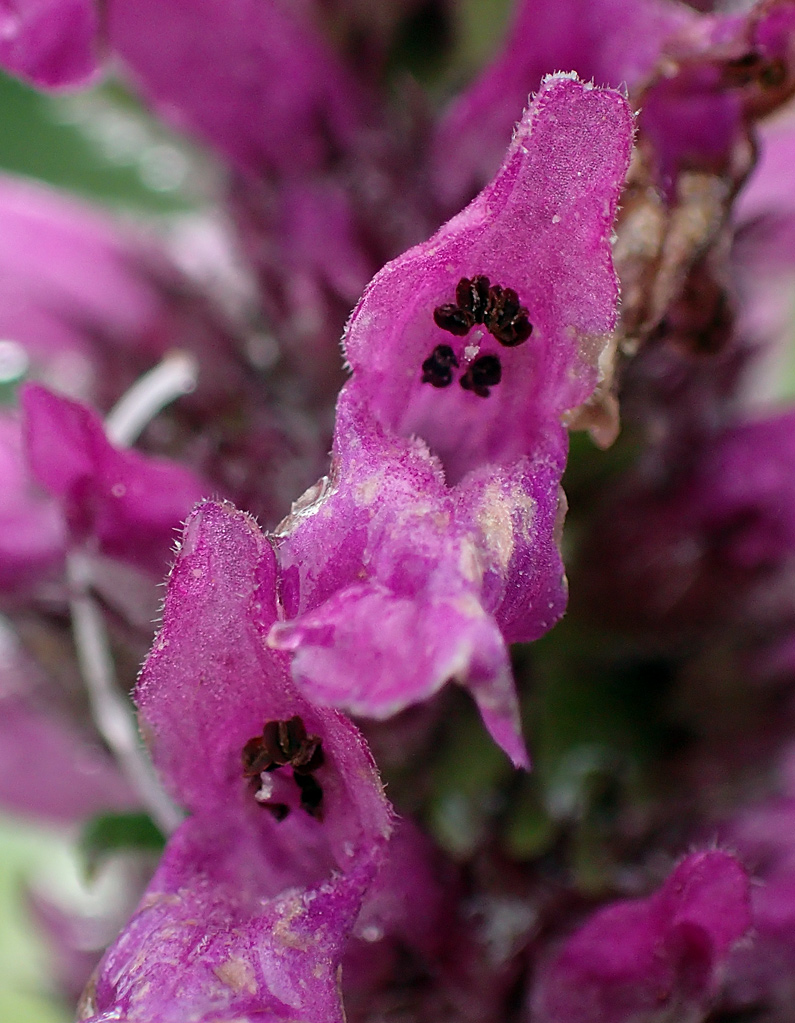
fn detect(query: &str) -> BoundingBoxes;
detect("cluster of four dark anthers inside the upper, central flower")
[423,274,533,398]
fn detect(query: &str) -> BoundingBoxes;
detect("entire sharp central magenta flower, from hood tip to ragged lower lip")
[269,75,632,765]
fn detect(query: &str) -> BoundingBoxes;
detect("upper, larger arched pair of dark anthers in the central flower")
[431,274,533,345]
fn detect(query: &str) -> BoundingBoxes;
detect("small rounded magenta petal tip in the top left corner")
[0,0,99,88]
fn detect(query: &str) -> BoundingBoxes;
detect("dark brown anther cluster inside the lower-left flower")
[242,715,324,820]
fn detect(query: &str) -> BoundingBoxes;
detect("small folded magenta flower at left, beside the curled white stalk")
[21,385,207,574]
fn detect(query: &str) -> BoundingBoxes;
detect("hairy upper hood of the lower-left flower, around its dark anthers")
[141,502,389,842]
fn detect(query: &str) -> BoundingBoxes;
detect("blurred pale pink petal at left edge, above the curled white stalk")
[0,176,174,378]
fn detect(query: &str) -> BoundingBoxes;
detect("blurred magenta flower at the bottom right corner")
[532,850,751,1023]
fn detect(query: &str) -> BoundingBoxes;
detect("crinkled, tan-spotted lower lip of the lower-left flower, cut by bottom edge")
[79,817,372,1023]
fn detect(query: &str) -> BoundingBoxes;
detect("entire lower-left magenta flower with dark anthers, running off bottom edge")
[80,503,392,1023]
